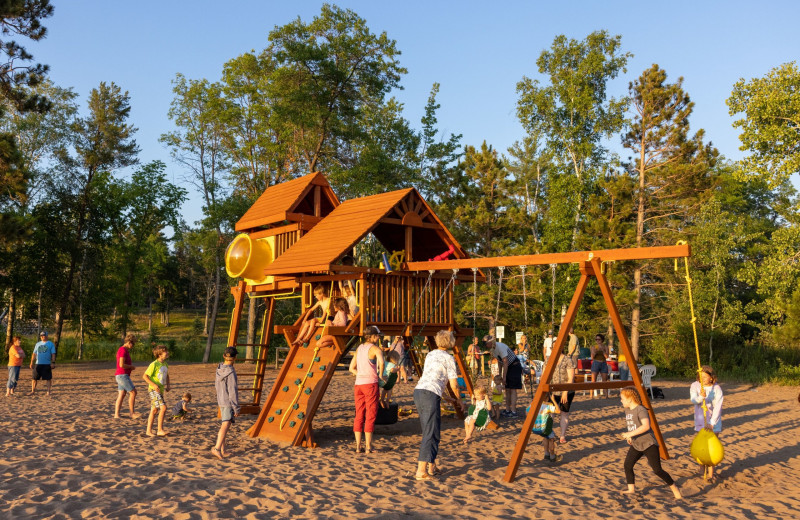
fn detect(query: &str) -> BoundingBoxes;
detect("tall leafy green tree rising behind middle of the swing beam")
[517,31,632,249]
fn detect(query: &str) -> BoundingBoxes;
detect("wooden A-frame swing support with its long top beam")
[408,244,691,482]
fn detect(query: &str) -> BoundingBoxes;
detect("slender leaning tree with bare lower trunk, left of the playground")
[55,82,139,345]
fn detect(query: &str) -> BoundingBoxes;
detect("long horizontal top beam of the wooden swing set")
[408,244,691,271]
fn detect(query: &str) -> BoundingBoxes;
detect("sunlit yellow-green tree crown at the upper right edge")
[727,62,800,187]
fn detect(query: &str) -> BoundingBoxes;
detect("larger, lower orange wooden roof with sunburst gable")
[264,188,467,275]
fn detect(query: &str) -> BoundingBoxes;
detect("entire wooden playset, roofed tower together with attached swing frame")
[226,173,690,482]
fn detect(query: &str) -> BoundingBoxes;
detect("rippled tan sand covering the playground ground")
[0,363,800,519]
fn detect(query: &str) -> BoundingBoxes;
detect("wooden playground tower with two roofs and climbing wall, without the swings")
[226,173,473,446]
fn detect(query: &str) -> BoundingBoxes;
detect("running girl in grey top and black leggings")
[619,388,681,498]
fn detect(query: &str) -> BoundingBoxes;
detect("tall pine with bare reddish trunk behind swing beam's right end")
[622,65,717,358]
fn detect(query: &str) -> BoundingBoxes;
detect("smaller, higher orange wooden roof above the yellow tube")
[235,173,339,232]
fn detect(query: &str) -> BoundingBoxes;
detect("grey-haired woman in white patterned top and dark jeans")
[414,330,462,480]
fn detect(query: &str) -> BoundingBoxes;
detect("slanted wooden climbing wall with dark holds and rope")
[247,335,349,446]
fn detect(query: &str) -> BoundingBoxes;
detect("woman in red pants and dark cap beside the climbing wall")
[350,325,383,453]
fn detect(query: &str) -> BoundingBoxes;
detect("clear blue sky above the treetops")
[27,0,800,222]
